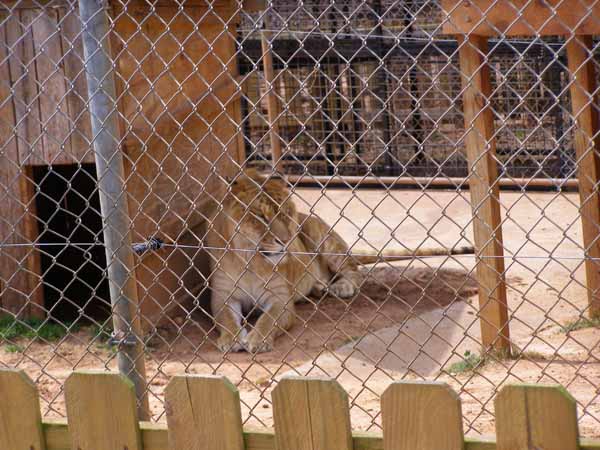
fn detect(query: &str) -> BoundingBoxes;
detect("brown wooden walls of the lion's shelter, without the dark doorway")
[0,1,243,322]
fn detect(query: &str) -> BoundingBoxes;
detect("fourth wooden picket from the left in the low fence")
[272,377,352,450]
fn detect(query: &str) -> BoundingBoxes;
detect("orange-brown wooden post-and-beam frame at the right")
[442,0,600,350]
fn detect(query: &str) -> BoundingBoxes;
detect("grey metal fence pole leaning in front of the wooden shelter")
[79,0,149,420]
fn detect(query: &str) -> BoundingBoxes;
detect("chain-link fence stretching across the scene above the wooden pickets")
[0,0,600,436]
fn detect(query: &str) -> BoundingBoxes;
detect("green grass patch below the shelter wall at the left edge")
[0,316,77,341]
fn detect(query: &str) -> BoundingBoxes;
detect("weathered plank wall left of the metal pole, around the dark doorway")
[0,7,94,316]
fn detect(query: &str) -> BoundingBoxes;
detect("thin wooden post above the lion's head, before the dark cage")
[260,24,284,174]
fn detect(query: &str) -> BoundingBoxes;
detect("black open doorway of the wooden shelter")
[33,164,110,322]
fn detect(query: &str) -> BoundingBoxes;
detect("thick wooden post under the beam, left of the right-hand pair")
[459,36,510,353]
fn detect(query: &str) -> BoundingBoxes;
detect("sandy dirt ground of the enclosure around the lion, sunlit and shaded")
[0,189,600,437]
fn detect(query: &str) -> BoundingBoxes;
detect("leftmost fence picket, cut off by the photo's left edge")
[0,369,46,450]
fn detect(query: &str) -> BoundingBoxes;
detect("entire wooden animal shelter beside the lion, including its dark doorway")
[0,1,252,326]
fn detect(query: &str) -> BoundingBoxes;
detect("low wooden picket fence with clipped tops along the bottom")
[0,370,600,450]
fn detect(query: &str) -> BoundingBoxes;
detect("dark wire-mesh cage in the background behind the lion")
[240,1,575,178]
